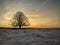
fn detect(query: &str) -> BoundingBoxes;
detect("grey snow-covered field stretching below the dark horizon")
[0,28,60,45]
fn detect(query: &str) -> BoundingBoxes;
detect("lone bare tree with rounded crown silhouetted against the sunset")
[11,12,29,28]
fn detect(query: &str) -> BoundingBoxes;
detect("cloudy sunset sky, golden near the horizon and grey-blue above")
[0,0,60,28]
